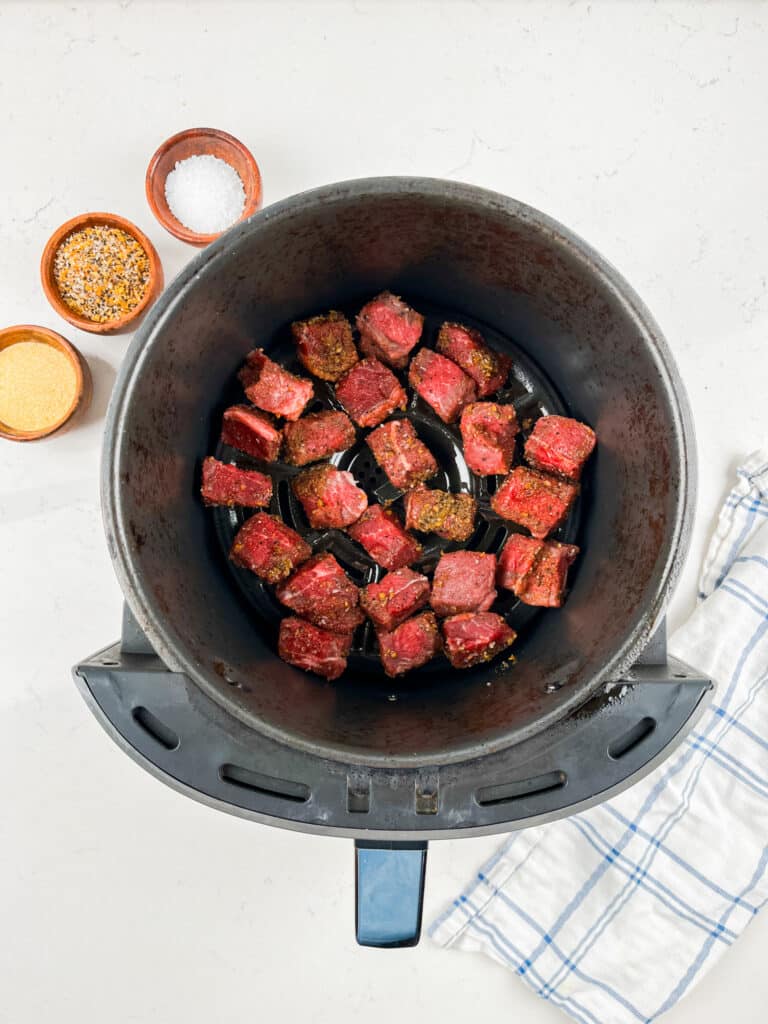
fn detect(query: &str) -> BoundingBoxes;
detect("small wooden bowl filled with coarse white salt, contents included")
[145,128,261,247]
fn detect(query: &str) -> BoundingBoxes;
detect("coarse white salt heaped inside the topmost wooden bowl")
[165,154,246,234]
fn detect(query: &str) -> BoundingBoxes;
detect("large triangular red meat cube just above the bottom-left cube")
[274,552,365,633]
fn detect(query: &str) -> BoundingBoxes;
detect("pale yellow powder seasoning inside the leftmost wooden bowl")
[0,341,77,431]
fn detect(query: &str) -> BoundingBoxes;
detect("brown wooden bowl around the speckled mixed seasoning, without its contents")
[40,213,163,334]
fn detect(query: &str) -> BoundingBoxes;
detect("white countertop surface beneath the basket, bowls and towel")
[0,0,768,1024]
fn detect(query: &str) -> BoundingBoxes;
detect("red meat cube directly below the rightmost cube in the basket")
[490,466,579,540]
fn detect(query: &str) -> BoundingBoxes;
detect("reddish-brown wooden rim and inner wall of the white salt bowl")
[144,128,263,249]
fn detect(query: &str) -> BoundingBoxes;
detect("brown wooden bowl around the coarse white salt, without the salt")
[144,128,262,249]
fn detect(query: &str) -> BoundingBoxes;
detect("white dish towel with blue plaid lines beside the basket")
[430,453,768,1024]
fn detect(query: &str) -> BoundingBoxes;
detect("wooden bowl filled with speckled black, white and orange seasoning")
[40,213,163,334]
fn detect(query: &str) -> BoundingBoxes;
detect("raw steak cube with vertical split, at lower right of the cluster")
[498,534,579,608]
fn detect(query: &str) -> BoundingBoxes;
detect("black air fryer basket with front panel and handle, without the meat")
[76,178,710,945]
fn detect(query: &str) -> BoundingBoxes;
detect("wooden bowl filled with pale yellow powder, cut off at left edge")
[0,324,91,441]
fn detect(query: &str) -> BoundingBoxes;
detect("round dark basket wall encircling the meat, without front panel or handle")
[103,179,693,764]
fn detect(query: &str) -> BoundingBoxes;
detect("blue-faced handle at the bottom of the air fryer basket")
[354,840,427,948]
